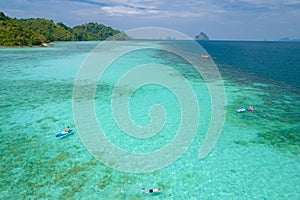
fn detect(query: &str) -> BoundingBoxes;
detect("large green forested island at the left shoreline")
[0,12,129,47]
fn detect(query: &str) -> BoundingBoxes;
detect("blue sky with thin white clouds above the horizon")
[0,0,300,40]
